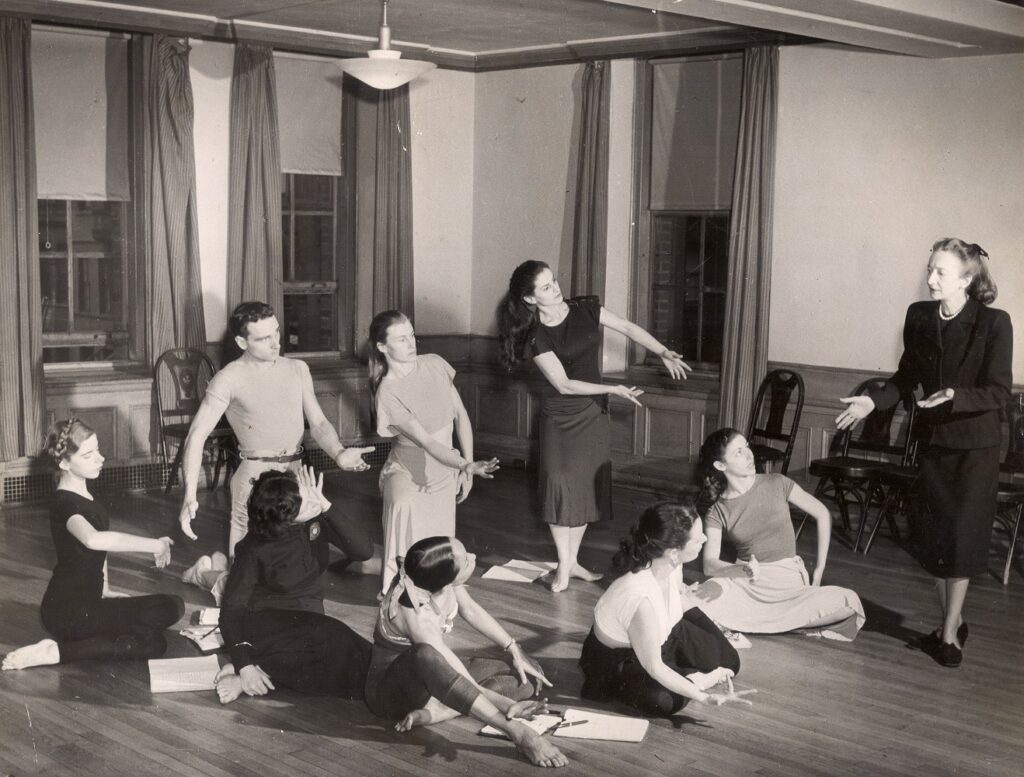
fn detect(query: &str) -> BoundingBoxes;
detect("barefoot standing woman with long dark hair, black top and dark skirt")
[498,260,690,593]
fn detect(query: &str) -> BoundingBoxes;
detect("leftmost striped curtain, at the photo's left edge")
[0,16,45,462]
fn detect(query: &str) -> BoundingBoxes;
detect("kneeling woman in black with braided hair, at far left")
[3,418,184,670]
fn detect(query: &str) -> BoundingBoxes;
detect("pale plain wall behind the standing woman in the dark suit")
[768,46,1024,383]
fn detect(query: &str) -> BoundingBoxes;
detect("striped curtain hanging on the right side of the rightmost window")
[718,46,778,429]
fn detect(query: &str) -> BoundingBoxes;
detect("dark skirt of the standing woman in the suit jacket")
[914,445,999,577]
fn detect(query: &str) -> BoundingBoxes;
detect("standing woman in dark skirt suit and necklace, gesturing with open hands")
[836,238,1013,666]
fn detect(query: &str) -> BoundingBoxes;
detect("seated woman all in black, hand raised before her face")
[216,468,373,704]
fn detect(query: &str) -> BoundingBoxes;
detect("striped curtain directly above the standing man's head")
[226,43,284,314]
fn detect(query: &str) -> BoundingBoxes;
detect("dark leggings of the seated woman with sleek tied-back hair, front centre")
[367,644,534,719]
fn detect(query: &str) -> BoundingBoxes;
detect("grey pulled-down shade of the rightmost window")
[650,57,743,211]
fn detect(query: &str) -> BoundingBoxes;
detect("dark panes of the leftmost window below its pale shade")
[39,200,128,363]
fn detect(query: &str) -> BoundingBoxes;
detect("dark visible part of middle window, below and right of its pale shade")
[281,75,355,355]
